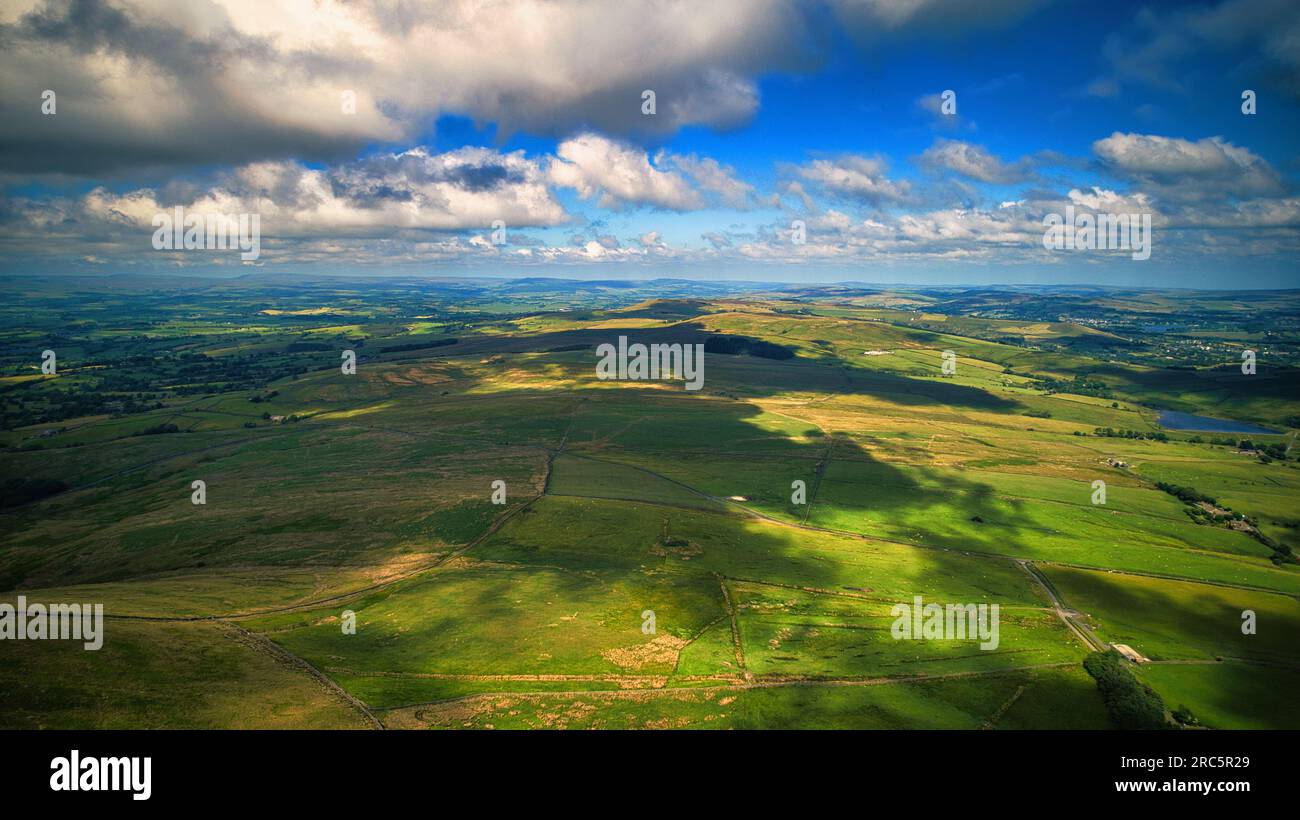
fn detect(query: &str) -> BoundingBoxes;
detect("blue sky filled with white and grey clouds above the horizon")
[0,0,1300,288]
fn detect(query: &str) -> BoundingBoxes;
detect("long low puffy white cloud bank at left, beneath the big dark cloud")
[0,148,569,265]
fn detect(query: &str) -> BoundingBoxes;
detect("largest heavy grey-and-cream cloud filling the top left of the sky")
[0,0,814,175]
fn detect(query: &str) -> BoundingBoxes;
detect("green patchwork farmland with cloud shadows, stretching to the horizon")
[0,283,1300,729]
